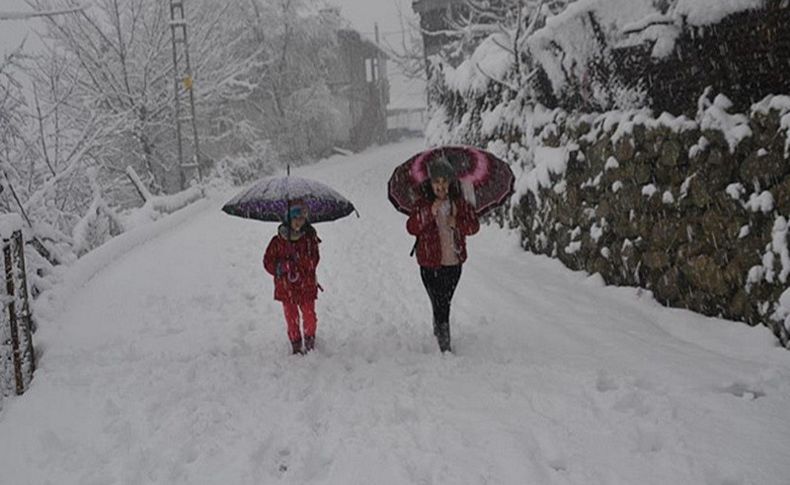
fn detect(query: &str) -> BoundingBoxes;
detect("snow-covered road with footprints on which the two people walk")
[0,141,790,485]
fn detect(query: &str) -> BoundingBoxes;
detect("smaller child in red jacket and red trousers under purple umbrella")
[263,202,321,354]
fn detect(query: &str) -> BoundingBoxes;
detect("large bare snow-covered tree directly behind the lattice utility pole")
[25,0,262,192]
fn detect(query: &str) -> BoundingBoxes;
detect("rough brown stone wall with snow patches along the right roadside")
[512,92,790,348]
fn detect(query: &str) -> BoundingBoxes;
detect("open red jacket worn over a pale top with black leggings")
[406,198,480,268]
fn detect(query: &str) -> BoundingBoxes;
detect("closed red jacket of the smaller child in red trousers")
[263,226,321,304]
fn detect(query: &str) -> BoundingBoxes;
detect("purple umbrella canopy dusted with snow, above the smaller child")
[222,176,356,223]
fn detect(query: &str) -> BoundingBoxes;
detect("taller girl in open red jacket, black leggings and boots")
[406,159,480,352]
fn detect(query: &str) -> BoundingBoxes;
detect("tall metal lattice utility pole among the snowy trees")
[170,0,202,189]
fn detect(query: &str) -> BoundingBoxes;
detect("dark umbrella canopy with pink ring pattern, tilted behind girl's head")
[388,146,516,216]
